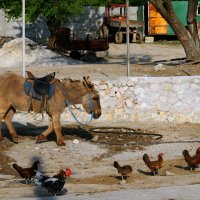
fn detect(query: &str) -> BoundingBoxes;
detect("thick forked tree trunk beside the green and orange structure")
[150,0,200,61]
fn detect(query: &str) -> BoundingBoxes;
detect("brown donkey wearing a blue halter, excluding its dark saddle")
[0,73,101,146]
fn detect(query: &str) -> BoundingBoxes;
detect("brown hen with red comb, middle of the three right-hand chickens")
[143,153,164,175]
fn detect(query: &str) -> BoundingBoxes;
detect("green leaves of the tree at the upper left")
[0,0,99,22]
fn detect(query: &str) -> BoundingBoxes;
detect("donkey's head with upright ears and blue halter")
[82,76,101,119]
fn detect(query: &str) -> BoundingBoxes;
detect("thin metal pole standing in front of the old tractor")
[126,0,130,76]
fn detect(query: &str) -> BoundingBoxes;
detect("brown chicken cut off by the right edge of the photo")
[183,149,200,171]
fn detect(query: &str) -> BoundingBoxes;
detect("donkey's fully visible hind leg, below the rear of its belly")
[4,109,18,143]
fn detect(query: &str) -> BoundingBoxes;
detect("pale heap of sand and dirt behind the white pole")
[0,38,81,67]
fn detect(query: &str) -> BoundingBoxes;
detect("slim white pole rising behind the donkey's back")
[22,0,25,77]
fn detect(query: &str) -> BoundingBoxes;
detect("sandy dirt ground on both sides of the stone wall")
[0,43,200,199]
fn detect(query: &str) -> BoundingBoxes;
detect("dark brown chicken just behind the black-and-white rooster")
[13,161,40,183]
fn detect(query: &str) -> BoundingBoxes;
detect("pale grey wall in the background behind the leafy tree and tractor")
[0,7,138,43]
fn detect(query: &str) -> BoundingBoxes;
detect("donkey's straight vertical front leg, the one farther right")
[52,113,65,146]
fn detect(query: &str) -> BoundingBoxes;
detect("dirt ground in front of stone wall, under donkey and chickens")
[0,123,200,199]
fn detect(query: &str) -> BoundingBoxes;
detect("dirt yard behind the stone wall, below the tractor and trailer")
[0,41,200,79]
